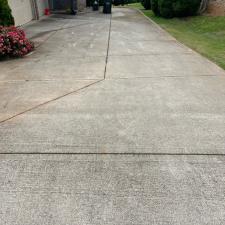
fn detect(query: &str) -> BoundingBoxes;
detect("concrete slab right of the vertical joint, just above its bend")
[106,54,224,79]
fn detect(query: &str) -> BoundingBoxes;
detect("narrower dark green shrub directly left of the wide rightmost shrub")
[158,0,174,18]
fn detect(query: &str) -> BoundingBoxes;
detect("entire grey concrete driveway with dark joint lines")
[0,8,225,225]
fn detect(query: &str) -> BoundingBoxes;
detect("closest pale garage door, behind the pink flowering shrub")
[8,0,33,26]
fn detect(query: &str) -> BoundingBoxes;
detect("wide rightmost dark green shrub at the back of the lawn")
[173,0,201,17]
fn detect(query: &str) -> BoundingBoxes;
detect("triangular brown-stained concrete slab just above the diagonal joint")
[0,80,95,121]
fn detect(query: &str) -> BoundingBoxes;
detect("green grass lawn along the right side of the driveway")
[129,3,225,69]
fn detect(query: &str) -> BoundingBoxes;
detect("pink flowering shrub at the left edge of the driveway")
[0,26,34,58]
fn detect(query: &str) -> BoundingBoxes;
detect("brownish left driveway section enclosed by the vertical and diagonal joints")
[0,13,110,121]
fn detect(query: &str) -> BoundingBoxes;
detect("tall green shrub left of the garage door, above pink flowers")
[0,0,14,26]
